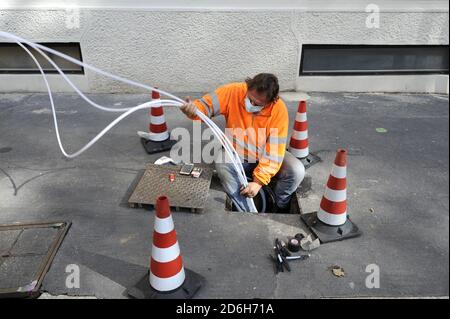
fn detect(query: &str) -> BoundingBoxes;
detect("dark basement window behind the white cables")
[0,43,84,74]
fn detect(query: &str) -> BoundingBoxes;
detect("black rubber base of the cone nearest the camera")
[127,268,205,299]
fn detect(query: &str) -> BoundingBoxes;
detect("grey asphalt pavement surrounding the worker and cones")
[0,93,449,298]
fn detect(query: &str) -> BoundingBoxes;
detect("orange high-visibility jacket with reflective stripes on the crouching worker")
[192,83,289,185]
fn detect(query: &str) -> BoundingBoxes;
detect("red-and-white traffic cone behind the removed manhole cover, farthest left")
[138,91,176,154]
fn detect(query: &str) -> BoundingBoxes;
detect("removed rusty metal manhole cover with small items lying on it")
[128,164,212,212]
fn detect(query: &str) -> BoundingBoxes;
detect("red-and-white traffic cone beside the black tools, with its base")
[302,149,361,243]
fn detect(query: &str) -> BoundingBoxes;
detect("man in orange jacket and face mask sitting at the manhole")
[181,73,305,213]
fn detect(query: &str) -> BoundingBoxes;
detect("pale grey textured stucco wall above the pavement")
[0,9,449,93]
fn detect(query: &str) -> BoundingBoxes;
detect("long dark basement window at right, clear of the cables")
[300,44,449,76]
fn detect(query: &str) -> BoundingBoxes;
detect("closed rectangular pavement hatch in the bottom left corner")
[0,222,70,298]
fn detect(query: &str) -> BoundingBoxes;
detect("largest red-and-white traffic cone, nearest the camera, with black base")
[128,196,204,299]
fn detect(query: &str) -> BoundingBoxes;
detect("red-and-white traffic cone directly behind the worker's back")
[288,101,320,168]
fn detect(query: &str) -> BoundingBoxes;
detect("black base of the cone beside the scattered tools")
[301,212,362,243]
